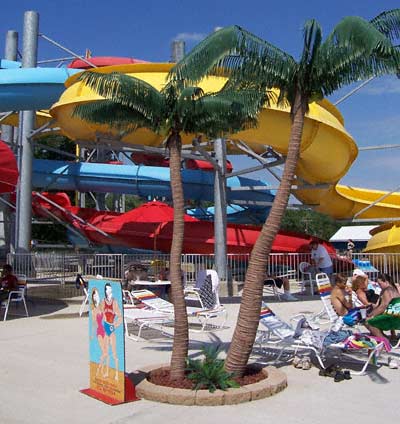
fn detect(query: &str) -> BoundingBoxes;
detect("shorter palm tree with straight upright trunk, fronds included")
[74,71,267,379]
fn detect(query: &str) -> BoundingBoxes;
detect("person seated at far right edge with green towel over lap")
[367,274,400,338]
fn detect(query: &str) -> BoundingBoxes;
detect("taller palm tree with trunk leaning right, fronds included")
[171,9,400,375]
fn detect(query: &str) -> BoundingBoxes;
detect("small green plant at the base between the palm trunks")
[186,346,240,393]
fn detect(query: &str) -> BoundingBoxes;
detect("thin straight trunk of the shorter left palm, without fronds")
[167,131,189,379]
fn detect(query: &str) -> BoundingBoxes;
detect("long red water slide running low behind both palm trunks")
[34,193,335,254]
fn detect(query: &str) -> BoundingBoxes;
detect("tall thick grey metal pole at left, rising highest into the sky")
[16,11,39,252]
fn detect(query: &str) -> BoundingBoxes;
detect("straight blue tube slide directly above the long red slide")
[32,159,273,202]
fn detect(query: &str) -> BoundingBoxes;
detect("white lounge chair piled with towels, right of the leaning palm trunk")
[256,303,384,375]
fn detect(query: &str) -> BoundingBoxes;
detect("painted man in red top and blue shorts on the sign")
[100,283,122,381]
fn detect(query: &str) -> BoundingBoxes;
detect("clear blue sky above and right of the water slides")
[0,0,400,189]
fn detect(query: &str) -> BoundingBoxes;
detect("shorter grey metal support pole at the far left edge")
[0,31,18,252]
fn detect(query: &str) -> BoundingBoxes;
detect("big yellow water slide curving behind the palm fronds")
[50,63,400,252]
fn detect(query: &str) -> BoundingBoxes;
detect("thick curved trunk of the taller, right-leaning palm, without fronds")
[225,92,308,376]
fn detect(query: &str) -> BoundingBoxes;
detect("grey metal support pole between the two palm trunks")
[214,138,227,281]
